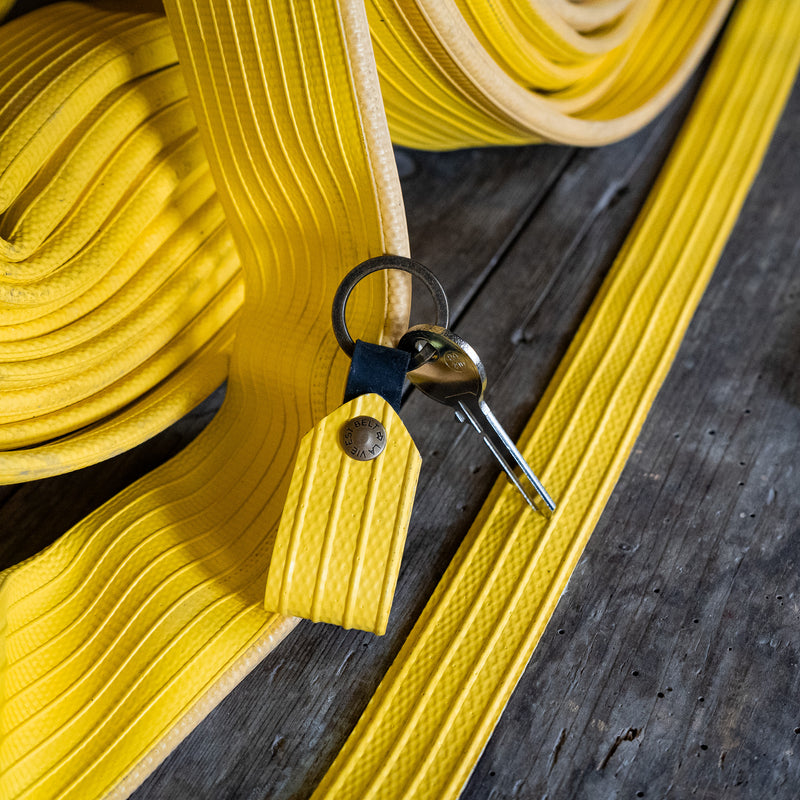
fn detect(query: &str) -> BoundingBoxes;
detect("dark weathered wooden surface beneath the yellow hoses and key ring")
[0,32,800,800]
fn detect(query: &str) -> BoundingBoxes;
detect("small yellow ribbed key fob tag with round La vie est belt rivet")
[264,394,422,635]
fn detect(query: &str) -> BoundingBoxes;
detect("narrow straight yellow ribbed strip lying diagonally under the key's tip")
[313,0,800,800]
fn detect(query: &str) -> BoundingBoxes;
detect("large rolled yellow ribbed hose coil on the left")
[0,3,236,476]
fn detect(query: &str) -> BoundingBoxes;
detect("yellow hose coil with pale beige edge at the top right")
[368,0,730,149]
